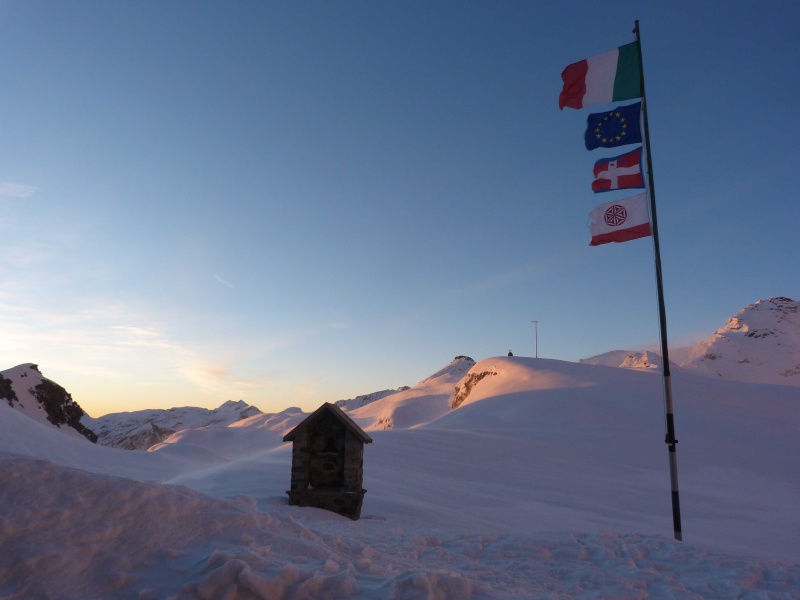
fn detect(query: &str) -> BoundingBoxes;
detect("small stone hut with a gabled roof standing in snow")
[283,402,372,520]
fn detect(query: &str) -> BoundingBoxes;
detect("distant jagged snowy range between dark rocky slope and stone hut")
[86,400,261,450]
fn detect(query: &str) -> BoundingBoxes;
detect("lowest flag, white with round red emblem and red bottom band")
[589,192,653,246]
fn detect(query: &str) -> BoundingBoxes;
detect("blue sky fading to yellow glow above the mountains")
[0,0,800,416]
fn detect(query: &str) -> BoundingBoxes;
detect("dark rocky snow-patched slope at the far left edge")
[0,363,97,442]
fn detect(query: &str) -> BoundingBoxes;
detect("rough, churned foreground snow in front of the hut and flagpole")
[0,455,800,600]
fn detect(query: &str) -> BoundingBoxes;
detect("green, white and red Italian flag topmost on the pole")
[558,42,642,110]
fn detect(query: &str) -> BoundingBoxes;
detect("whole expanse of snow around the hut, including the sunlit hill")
[0,357,800,600]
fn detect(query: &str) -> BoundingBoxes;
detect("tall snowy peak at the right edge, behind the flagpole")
[682,297,800,386]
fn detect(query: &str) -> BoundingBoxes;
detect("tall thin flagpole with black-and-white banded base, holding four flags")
[633,19,683,540]
